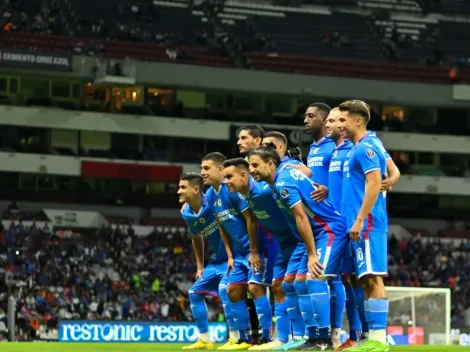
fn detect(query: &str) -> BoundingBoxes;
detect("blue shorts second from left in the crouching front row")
[228,248,277,285]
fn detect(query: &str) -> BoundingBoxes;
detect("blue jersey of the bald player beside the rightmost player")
[328,140,353,212]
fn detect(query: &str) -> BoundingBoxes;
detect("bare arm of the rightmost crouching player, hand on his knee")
[291,202,323,278]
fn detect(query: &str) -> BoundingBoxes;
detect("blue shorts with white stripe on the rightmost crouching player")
[299,231,348,277]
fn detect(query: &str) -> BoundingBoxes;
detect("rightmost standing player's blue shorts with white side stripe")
[351,231,388,278]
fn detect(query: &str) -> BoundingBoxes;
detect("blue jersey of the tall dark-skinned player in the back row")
[307,137,336,187]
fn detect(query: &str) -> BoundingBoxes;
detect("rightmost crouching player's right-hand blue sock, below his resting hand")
[307,280,331,339]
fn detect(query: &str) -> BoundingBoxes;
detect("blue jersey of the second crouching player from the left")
[206,184,250,257]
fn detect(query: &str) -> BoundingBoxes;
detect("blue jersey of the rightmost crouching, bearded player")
[273,165,346,237]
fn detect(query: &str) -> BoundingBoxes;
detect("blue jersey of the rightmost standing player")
[341,135,388,231]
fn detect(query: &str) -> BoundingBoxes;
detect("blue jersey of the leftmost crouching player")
[181,195,227,264]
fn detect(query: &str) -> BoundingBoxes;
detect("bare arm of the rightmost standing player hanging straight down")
[349,170,382,241]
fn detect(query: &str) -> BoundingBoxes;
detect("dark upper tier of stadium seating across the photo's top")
[0,1,470,83]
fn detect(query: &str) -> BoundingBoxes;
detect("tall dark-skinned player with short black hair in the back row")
[304,103,346,346]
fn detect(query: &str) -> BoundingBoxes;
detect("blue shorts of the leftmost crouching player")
[189,263,227,296]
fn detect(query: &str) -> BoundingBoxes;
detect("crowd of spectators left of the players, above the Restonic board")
[0,213,223,339]
